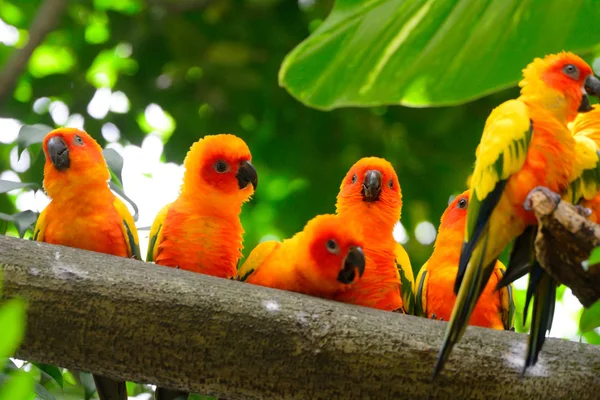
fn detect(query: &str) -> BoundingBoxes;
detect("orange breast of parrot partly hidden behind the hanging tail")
[427,260,504,330]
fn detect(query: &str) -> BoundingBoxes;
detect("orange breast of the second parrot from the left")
[155,202,243,278]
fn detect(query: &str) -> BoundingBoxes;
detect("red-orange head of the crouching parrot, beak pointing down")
[303,214,365,285]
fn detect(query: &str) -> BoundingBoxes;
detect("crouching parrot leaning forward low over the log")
[238,214,365,299]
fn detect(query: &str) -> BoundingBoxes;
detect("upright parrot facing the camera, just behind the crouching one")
[334,157,414,313]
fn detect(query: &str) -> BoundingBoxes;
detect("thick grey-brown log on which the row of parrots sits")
[0,237,600,399]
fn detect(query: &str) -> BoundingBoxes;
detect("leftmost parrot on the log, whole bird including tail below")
[33,128,141,400]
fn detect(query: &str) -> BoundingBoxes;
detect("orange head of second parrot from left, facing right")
[182,134,258,204]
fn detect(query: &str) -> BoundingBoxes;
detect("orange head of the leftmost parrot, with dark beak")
[42,128,110,198]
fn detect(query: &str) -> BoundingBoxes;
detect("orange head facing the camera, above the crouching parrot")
[336,157,402,224]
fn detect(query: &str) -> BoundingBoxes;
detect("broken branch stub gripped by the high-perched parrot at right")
[529,189,600,307]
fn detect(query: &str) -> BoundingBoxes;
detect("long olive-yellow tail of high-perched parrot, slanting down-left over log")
[433,235,496,379]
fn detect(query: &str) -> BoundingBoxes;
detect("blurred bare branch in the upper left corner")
[0,0,68,104]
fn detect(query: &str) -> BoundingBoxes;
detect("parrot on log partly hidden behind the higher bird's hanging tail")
[414,191,515,330]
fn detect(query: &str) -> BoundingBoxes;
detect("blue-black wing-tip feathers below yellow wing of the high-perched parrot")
[454,179,508,293]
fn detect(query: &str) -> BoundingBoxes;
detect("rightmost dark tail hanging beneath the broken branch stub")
[522,265,556,374]
